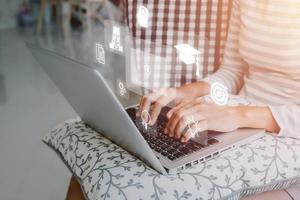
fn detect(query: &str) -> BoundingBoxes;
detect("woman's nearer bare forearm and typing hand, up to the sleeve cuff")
[165,99,284,142]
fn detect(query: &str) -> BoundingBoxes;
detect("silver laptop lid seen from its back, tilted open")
[27,44,167,174]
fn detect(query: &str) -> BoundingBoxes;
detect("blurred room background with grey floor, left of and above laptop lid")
[0,0,123,200]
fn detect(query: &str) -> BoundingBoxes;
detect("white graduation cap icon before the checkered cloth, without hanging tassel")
[174,44,201,65]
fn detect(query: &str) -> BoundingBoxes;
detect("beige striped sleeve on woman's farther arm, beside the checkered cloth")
[203,0,248,94]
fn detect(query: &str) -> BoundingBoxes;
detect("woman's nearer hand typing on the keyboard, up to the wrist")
[165,99,241,142]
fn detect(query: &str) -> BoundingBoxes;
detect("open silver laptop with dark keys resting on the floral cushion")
[27,44,265,175]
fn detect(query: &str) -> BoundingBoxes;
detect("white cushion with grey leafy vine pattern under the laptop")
[43,119,300,200]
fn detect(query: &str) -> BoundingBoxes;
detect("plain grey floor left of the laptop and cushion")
[0,29,76,200]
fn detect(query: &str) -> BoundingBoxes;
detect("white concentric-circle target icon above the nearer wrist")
[210,82,229,106]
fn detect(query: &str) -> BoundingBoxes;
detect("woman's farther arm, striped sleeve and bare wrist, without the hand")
[178,0,248,97]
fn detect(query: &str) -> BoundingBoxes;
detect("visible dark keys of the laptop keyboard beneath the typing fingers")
[127,108,218,160]
